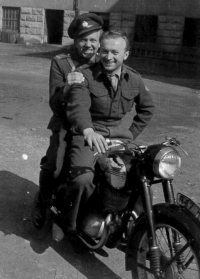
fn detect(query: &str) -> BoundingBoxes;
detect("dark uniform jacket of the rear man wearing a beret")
[48,48,99,131]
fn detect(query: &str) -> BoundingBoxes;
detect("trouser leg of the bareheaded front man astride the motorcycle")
[62,135,96,231]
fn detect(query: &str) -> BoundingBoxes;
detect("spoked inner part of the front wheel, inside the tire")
[137,224,200,279]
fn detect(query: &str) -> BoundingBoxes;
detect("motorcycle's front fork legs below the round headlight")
[141,177,182,277]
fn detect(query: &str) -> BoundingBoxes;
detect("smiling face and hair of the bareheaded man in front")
[100,37,129,74]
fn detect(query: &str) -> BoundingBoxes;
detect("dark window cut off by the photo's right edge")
[183,18,200,47]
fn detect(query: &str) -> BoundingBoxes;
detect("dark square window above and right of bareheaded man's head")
[134,15,158,43]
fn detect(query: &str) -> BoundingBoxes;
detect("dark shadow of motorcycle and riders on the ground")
[0,171,121,279]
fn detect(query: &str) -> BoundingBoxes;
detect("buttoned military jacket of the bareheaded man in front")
[67,62,154,139]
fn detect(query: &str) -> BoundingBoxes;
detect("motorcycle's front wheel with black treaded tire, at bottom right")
[129,208,200,279]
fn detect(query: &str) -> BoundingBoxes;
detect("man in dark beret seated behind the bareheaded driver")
[31,13,103,234]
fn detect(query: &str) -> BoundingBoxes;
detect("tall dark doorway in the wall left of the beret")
[46,10,64,45]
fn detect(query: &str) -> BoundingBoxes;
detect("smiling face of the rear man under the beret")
[75,31,101,60]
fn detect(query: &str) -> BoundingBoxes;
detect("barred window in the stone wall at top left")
[2,7,20,31]
